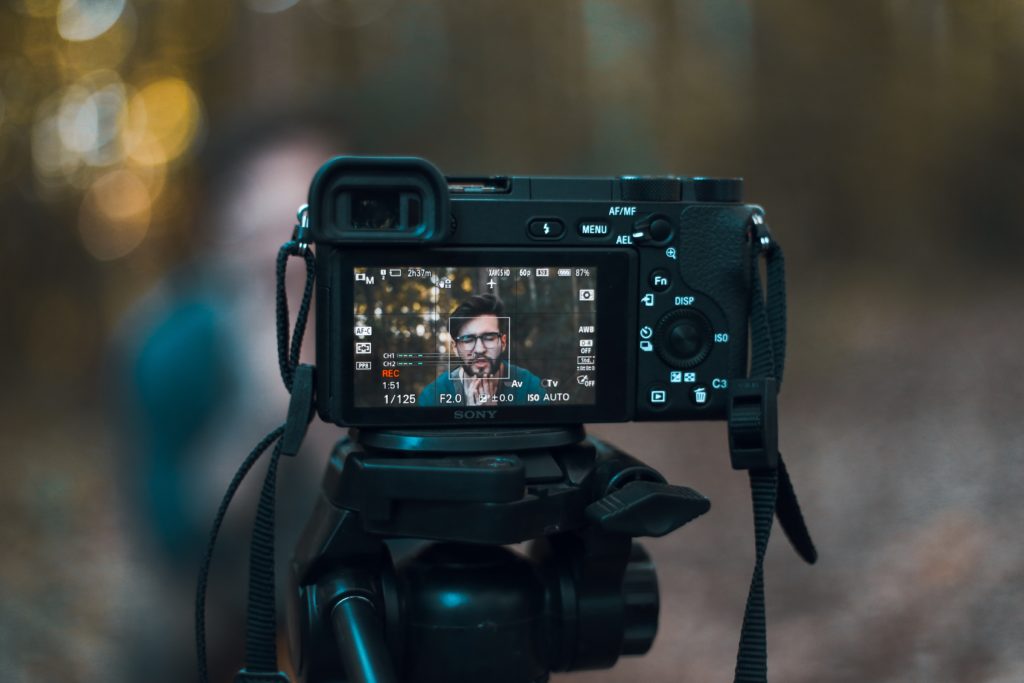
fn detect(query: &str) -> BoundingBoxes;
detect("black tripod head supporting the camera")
[289,426,711,683]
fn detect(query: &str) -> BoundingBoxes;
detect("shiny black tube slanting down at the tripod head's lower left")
[331,595,398,683]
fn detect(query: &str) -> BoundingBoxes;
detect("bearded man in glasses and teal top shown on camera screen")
[419,294,545,405]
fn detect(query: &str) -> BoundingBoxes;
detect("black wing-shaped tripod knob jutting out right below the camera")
[585,481,711,537]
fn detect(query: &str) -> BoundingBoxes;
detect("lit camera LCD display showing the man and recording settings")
[351,263,600,410]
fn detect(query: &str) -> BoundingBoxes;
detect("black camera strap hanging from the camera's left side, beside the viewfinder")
[196,223,315,683]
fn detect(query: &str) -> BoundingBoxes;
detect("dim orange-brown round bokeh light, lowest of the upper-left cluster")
[78,169,153,261]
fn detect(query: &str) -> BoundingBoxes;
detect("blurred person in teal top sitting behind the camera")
[112,120,339,683]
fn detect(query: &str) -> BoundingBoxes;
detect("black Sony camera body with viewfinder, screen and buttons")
[308,157,762,427]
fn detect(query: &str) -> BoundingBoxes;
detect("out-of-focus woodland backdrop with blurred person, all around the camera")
[0,0,1024,683]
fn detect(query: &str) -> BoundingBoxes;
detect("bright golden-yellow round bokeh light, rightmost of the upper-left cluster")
[122,77,202,166]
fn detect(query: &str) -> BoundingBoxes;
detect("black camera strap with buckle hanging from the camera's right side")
[729,213,818,683]
